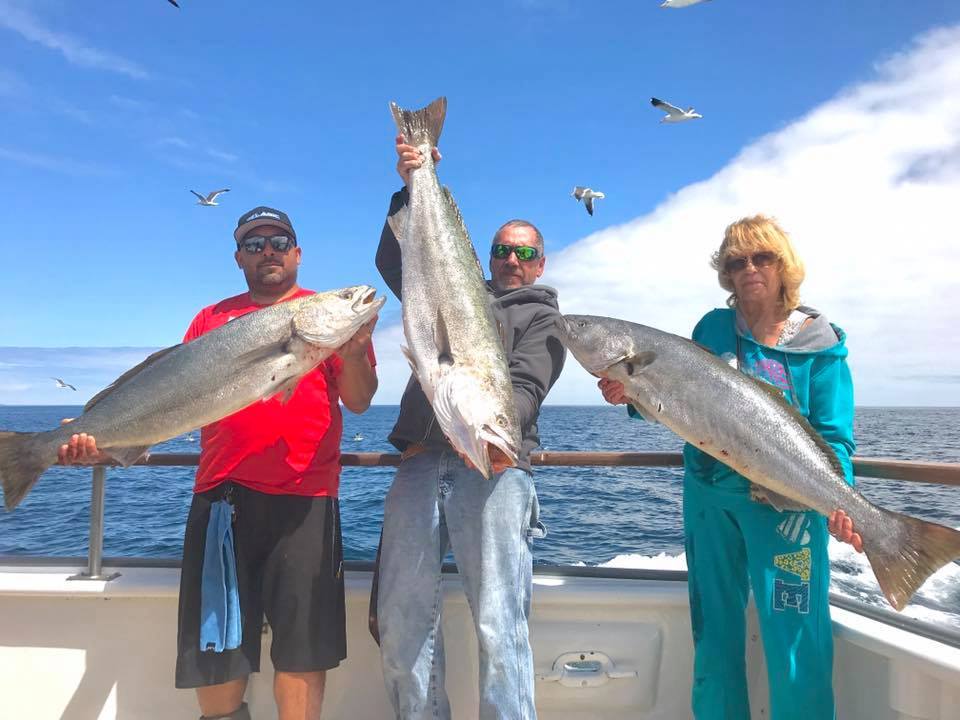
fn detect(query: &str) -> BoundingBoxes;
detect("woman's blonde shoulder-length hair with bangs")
[710,215,806,312]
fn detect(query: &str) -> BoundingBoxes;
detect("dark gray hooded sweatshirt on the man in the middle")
[377,189,566,472]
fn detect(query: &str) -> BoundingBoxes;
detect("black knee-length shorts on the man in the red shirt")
[176,483,347,688]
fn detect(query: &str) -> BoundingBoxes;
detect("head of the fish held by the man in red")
[293,285,386,348]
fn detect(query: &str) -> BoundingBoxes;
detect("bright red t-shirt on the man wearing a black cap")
[183,289,376,497]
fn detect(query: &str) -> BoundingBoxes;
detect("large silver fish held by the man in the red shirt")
[0,285,385,510]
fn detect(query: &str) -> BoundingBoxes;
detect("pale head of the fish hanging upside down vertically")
[433,369,521,478]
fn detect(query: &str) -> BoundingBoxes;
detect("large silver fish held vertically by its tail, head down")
[388,98,521,477]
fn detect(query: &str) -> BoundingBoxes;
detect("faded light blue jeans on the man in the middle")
[377,450,543,720]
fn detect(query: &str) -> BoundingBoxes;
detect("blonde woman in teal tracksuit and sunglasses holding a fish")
[600,216,860,720]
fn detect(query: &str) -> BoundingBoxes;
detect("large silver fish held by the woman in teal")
[558,315,960,610]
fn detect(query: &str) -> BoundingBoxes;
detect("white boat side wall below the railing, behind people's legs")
[0,565,960,720]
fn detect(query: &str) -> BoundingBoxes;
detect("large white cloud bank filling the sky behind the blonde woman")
[368,27,960,405]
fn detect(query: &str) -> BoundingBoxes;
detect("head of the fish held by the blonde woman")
[557,315,653,377]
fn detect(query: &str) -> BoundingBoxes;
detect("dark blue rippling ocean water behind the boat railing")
[0,406,960,627]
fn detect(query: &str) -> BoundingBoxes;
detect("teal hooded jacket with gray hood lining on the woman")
[628,307,856,497]
